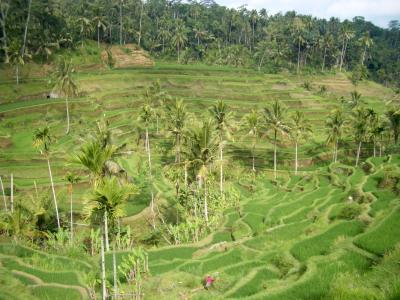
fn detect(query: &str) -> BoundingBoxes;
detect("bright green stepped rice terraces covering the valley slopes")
[0,64,400,300]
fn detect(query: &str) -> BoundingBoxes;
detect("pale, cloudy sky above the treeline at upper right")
[216,0,400,28]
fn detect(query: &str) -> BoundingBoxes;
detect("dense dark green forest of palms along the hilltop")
[0,0,400,85]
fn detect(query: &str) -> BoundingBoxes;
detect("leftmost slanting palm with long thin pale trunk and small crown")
[33,126,61,230]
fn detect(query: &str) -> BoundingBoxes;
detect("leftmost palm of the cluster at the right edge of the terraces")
[326,109,346,162]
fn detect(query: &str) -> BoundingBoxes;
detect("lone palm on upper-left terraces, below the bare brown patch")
[53,58,78,134]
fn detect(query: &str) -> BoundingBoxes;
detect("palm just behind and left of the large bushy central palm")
[167,100,187,164]
